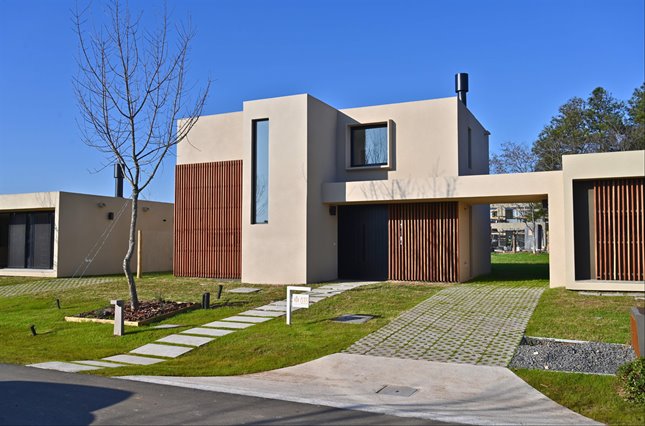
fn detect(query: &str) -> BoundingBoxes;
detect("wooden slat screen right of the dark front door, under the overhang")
[388,202,459,282]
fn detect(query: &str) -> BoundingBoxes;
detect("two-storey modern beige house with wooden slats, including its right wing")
[173,75,645,291]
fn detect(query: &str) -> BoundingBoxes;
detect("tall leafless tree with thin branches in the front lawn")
[73,0,210,310]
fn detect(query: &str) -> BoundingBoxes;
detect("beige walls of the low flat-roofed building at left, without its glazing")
[0,192,173,277]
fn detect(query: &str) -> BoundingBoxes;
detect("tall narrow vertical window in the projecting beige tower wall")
[251,119,269,223]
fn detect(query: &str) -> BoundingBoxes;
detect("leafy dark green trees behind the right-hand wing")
[533,86,645,170]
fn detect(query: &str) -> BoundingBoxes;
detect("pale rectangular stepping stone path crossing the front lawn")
[29,282,374,372]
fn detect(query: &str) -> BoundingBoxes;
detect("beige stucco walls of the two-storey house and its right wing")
[177,88,645,290]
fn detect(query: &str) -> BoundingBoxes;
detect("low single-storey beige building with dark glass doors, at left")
[0,192,173,277]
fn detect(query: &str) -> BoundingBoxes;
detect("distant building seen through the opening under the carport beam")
[490,203,546,252]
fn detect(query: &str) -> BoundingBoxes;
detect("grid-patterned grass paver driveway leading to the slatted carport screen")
[344,284,542,367]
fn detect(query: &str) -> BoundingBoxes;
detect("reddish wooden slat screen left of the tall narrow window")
[173,160,242,278]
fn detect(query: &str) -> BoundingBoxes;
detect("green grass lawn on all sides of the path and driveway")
[0,253,645,424]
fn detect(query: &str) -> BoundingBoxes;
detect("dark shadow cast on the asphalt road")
[0,381,132,425]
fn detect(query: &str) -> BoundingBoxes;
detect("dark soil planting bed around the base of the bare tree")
[65,300,199,326]
